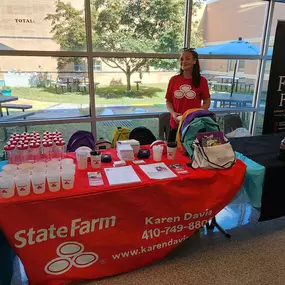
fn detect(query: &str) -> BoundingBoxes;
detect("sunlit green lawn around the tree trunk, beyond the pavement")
[12,84,167,105]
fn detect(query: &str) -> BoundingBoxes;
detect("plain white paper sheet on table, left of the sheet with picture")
[104,165,141,185]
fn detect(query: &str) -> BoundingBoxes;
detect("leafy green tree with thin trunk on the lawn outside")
[45,0,202,91]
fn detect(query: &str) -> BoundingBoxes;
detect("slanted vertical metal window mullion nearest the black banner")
[249,1,275,134]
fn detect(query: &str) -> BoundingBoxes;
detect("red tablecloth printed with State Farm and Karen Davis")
[0,150,246,284]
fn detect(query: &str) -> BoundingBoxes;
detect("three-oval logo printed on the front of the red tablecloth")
[45,241,99,275]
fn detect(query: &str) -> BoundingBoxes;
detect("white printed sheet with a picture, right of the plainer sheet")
[139,162,177,179]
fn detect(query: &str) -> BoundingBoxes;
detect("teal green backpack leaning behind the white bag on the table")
[180,113,220,157]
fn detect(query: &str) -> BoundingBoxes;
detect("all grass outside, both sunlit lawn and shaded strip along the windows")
[0,84,266,159]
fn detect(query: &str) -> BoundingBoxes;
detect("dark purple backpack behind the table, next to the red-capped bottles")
[66,131,95,152]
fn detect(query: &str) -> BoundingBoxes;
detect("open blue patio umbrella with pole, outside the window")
[196,38,272,96]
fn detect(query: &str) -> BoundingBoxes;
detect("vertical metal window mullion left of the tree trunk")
[85,0,97,138]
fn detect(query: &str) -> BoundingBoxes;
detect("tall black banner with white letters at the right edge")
[263,21,285,134]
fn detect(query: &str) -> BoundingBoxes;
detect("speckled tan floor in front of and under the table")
[12,191,285,285]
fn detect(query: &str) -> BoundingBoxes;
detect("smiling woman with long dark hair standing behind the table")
[165,49,211,142]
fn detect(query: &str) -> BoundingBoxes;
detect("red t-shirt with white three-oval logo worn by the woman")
[165,75,210,130]
